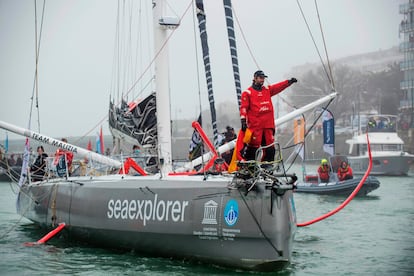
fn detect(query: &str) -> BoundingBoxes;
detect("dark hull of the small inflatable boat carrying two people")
[295,176,380,196]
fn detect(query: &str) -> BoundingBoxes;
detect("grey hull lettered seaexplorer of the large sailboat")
[18,176,296,270]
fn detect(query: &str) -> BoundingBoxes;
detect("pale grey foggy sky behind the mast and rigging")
[0,0,406,139]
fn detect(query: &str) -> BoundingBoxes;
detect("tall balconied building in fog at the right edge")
[400,0,414,128]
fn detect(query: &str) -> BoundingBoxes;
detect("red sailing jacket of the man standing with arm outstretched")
[240,80,290,130]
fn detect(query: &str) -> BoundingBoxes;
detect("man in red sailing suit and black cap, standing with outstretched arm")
[240,70,297,162]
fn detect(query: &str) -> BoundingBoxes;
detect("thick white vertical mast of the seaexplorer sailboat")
[152,0,179,175]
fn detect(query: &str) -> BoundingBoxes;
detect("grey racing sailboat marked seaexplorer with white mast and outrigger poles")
[0,0,336,271]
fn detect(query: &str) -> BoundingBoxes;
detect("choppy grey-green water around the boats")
[0,172,414,275]
